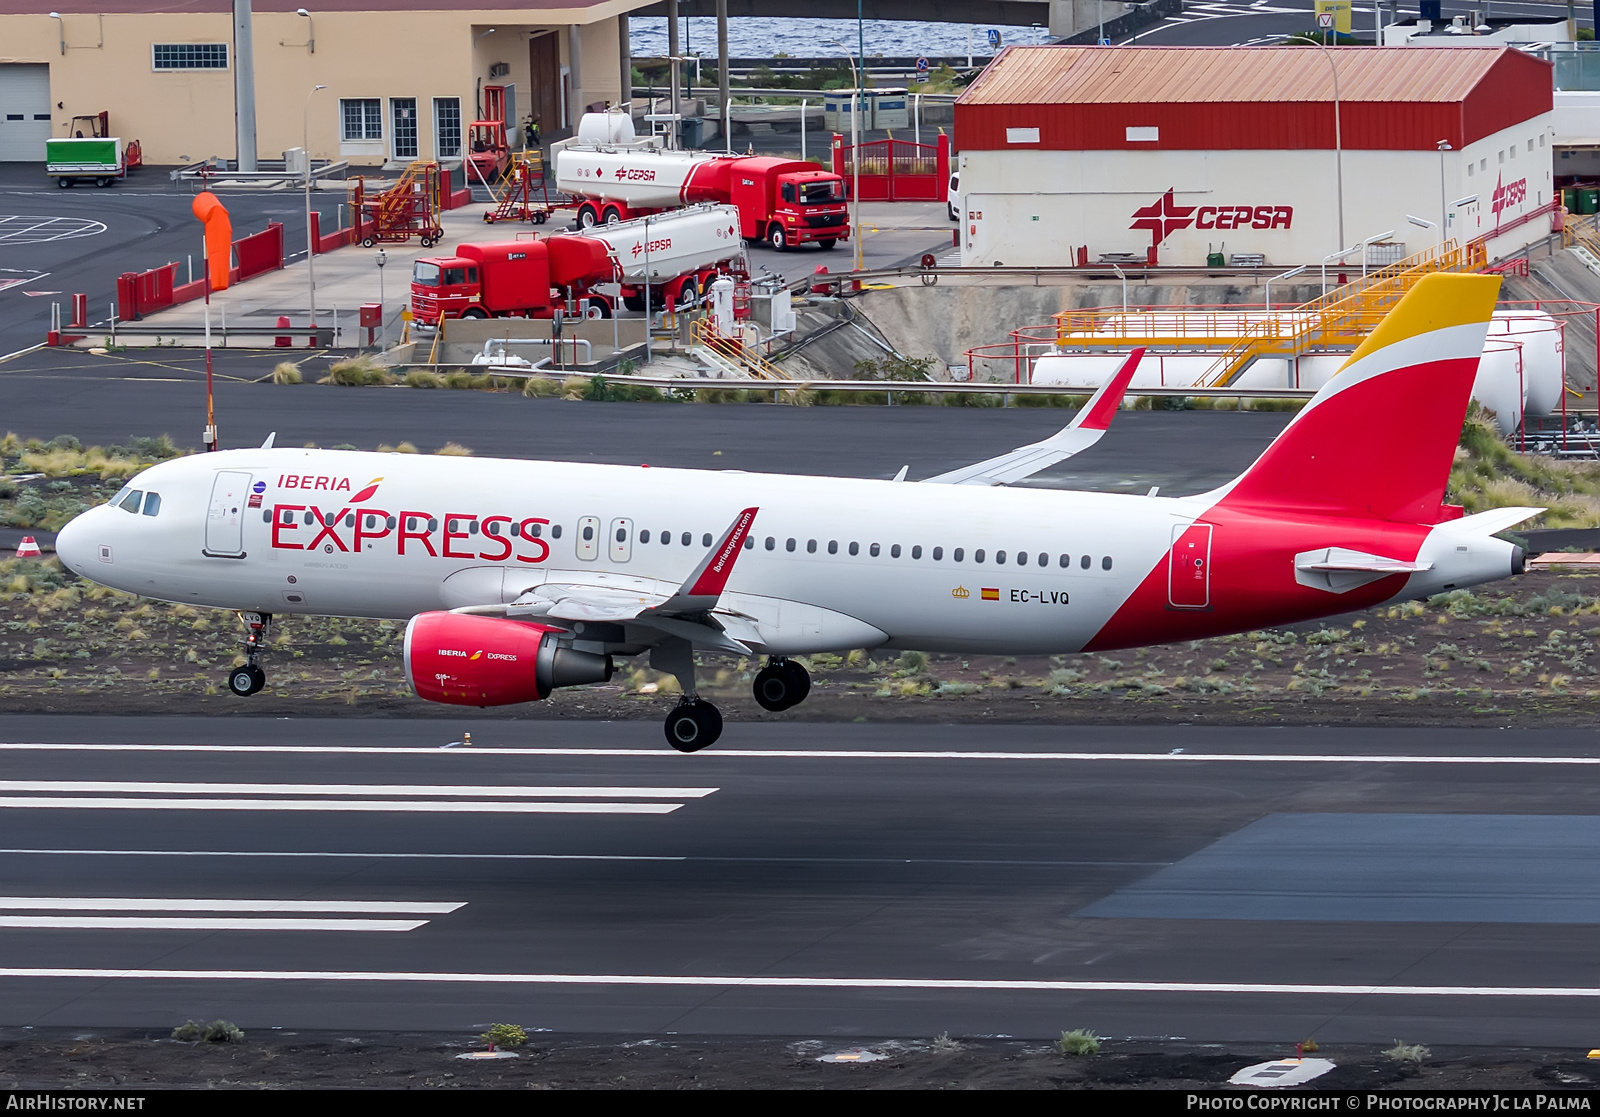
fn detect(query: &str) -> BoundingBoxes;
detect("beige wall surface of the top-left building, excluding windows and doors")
[0,0,643,165]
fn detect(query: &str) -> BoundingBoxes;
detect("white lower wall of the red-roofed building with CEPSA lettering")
[960,114,1554,266]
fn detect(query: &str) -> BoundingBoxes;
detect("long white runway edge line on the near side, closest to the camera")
[0,967,1600,999]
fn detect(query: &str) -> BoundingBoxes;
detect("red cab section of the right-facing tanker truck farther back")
[683,155,850,251]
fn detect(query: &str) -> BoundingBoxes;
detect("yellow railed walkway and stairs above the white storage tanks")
[1054,240,1484,387]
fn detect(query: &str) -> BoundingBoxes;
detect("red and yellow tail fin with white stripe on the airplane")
[1221,274,1501,523]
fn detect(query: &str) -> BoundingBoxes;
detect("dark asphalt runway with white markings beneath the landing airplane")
[0,717,1600,1045]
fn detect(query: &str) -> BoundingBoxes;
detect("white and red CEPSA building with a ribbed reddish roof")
[955,45,1558,267]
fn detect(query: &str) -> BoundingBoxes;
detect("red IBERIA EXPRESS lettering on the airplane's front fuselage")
[270,492,550,563]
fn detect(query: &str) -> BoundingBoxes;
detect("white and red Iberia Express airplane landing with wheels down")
[56,275,1539,752]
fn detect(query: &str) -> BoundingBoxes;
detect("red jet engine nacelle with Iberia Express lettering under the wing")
[405,613,611,706]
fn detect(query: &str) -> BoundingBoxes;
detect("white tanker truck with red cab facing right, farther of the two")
[555,114,850,251]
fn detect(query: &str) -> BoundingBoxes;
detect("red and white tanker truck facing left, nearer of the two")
[411,205,749,326]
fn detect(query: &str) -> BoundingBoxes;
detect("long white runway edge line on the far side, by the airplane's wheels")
[0,743,1600,764]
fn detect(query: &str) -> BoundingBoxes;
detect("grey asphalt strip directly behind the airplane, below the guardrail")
[0,350,1288,494]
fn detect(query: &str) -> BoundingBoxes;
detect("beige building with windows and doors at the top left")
[0,0,645,165]
